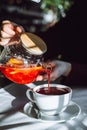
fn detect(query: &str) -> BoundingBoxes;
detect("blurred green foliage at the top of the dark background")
[42,0,74,21]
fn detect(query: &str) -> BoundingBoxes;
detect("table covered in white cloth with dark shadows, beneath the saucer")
[0,83,87,130]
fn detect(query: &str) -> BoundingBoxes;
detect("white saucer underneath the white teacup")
[24,101,81,123]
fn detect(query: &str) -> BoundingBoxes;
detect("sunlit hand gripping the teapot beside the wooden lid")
[0,20,24,46]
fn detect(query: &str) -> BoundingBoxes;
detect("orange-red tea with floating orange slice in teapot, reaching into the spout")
[0,58,50,84]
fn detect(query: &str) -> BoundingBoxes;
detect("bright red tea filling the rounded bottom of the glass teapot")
[0,66,42,84]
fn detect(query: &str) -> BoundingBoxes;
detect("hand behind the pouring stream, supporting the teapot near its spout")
[36,60,71,81]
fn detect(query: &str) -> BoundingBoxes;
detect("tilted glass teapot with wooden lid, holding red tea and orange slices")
[0,32,47,84]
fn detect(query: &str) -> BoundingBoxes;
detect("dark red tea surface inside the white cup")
[36,86,70,95]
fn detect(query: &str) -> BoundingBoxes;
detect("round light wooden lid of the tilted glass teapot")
[20,32,47,55]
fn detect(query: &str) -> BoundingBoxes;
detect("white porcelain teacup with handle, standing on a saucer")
[26,84,72,116]
